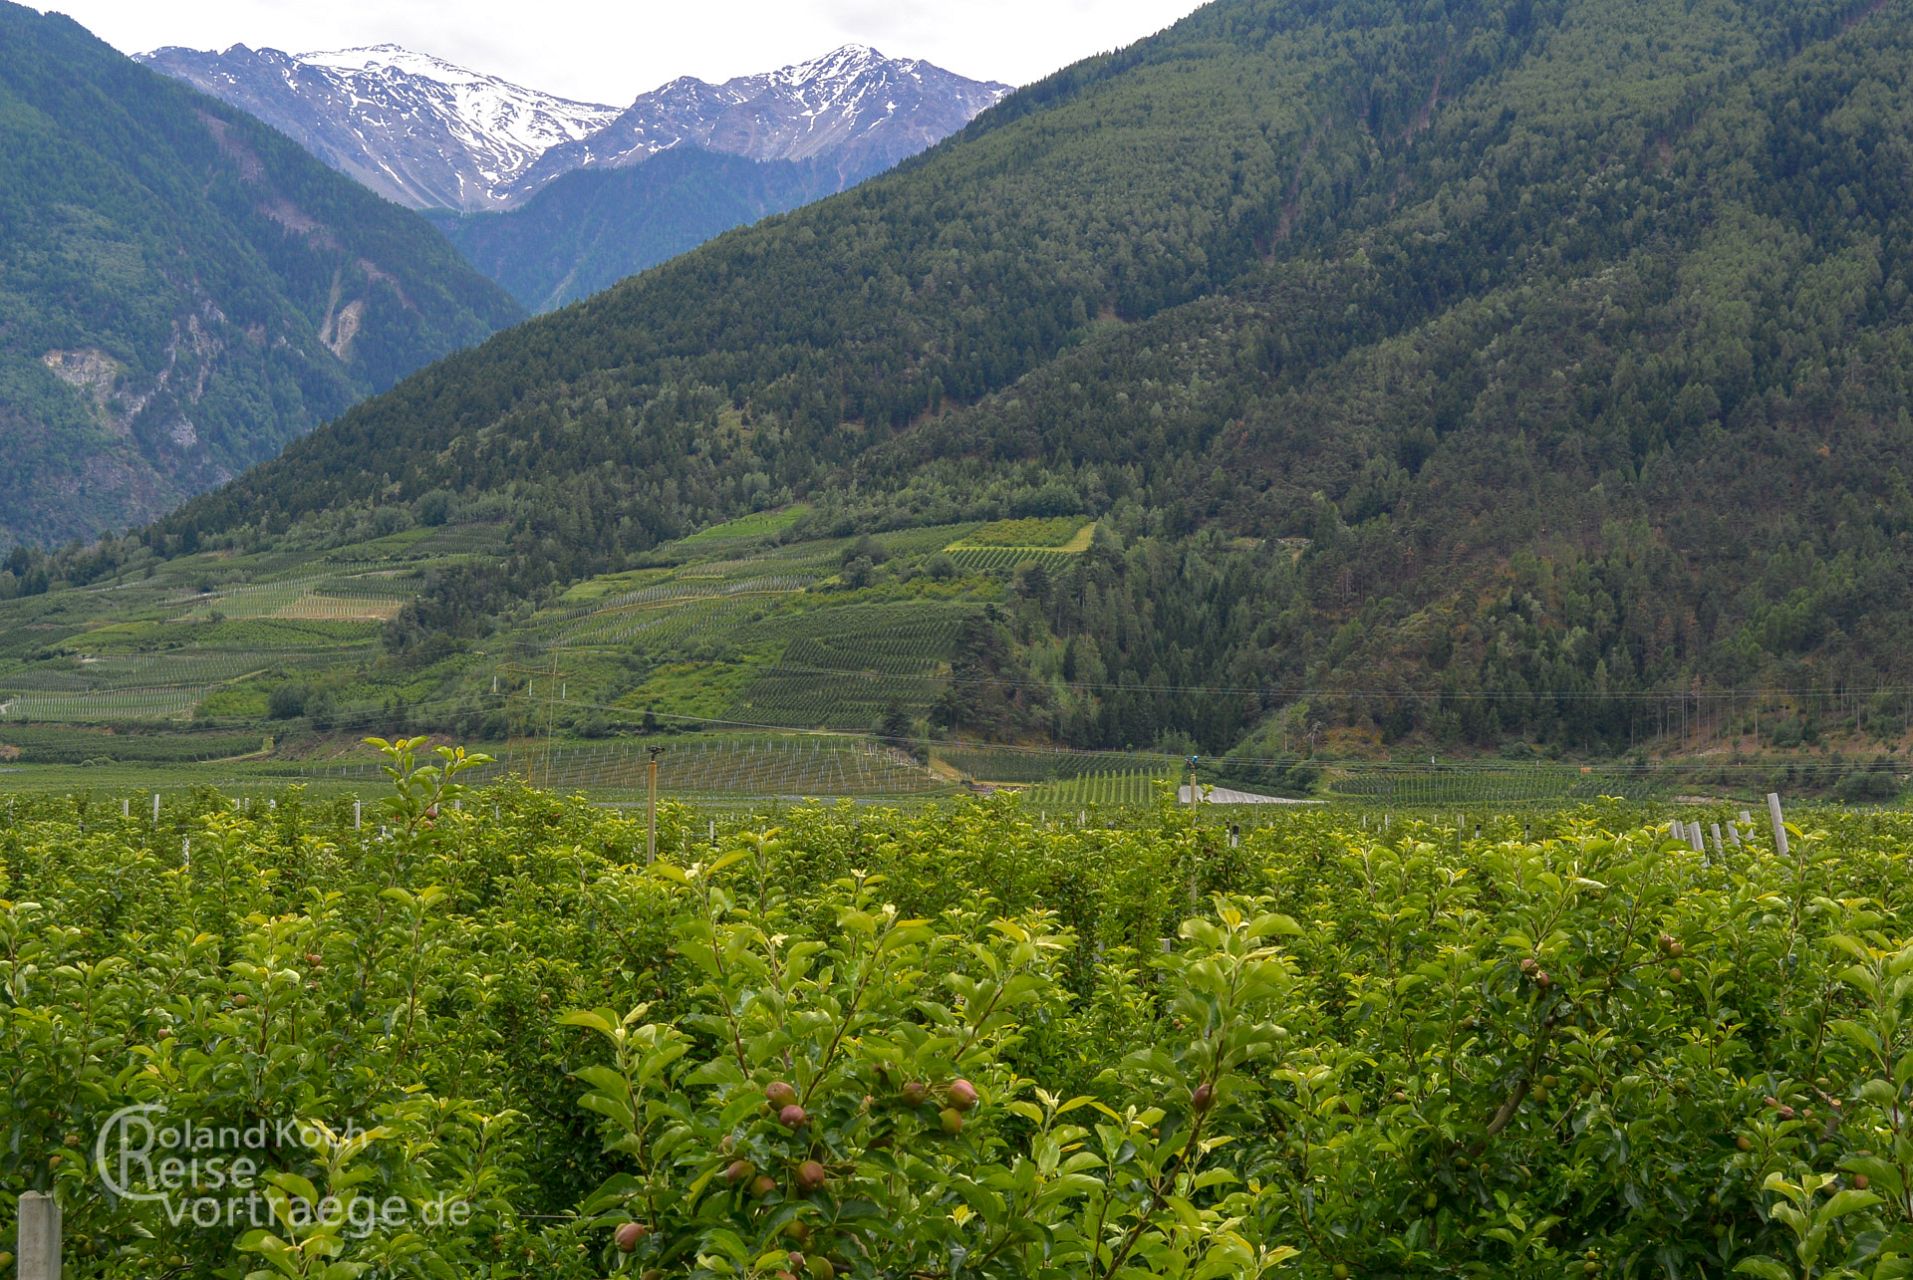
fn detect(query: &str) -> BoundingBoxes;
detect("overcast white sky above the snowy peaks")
[27,0,1199,107]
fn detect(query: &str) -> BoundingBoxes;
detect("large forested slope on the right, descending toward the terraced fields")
[82,0,1913,750]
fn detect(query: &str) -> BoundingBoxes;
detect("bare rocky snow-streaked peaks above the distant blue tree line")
[140,44,1010,212]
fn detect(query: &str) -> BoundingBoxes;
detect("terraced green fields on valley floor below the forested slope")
[0,511,1882,811]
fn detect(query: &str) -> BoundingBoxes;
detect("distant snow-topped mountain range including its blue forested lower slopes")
[143,44,1010,310]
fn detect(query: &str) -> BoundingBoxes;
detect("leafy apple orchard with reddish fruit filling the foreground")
[0,739,1913,1280]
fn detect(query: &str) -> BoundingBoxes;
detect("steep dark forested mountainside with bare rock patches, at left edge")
[0,2,520,541]
